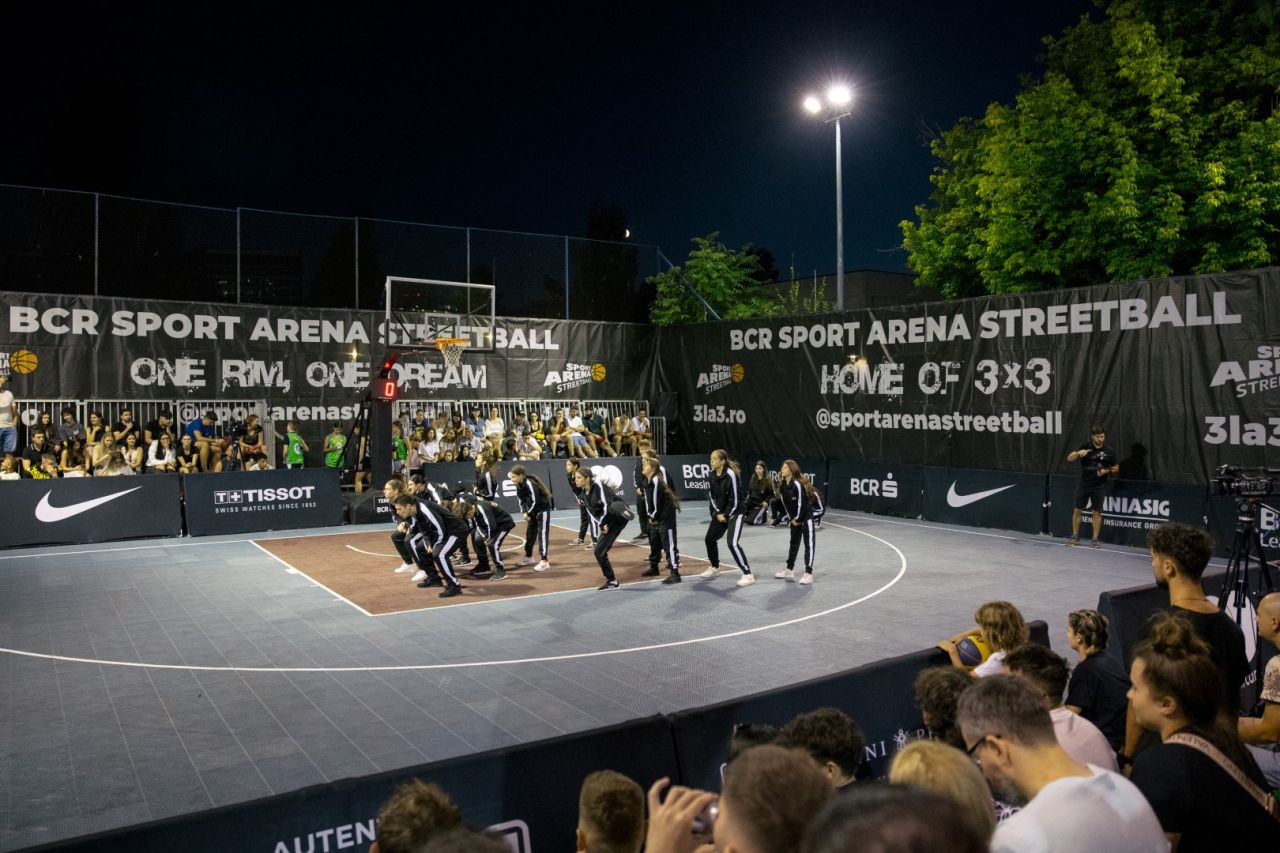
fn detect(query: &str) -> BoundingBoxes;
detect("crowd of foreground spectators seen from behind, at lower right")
[358,524,1280,853]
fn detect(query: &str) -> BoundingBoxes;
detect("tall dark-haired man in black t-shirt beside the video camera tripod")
[1121,521,1249,763]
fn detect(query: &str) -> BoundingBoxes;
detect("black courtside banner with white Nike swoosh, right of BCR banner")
[924,467,1044,533]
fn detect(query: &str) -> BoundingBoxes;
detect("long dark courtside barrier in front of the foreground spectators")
[32,620,1048,853]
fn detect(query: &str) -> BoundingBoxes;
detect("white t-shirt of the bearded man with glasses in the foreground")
[991,766,1169,853]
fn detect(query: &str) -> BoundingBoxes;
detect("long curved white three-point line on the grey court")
[0,523,906,674]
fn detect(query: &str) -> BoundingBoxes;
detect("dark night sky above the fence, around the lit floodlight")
[0,0,1098,275]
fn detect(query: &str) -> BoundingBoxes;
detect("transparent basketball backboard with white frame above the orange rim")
[383,275,495,352]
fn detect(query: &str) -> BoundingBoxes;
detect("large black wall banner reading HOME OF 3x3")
[659,268,1280,483]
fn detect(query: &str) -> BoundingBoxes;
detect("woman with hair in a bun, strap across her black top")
[1129,615,1280,853]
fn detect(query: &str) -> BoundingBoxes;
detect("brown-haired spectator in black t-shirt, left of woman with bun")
[1065,610,1129,752]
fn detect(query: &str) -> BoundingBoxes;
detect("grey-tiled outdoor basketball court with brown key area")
[0,503,1151,849]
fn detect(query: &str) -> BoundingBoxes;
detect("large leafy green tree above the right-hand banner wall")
[901,0,1280,297]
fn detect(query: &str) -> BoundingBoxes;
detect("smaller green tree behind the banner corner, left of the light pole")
[645,232,780,325]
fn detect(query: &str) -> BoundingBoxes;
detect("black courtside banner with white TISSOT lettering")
[182,467,342,537]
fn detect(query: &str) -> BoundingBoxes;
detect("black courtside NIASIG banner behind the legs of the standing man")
[1048,476,1208,548]
